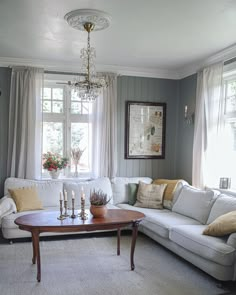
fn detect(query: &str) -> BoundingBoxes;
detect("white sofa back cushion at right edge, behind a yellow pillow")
[207,194,236,224]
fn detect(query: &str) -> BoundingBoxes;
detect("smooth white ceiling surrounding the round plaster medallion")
[0,0,236,78]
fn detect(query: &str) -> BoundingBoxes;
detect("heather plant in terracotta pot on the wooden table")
[90,189,111,217]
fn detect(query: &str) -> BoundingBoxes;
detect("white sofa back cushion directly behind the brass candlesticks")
[64,177,113,209]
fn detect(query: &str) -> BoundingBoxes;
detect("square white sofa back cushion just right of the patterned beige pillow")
[172,186,219,224]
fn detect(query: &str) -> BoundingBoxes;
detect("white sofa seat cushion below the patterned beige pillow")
[118,204,200,239]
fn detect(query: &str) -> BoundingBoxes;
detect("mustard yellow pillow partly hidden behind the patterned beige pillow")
[152,179,180,209]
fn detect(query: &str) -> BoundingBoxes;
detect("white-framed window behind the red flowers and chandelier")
[42,81,92,176]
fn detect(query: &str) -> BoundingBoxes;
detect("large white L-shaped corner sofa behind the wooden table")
[0,177,236,281]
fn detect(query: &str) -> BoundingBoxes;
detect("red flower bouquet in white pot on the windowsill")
[43,152,68,179]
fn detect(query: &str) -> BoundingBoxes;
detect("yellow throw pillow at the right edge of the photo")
[203,211,236,237]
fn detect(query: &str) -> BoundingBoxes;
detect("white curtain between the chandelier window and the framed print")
[91,74,117,178]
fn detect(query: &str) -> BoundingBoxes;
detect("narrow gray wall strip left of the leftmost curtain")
[0,68,11,196]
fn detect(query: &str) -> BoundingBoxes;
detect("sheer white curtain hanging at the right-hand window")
[192,62,224,188]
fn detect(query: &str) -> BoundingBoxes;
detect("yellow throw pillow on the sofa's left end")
[8,187,43,212]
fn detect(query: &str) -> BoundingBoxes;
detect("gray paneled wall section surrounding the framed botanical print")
[117,76,179,178]
